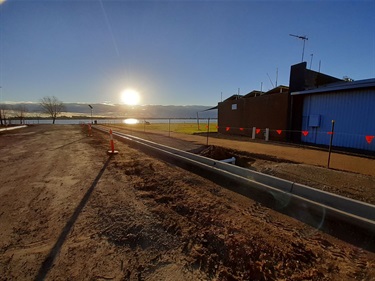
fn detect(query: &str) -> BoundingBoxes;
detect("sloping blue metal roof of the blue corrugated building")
[291,78,375,95]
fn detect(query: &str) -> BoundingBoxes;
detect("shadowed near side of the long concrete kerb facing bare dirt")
[114,130,375,235]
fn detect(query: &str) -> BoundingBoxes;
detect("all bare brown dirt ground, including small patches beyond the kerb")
[0,125,375,281]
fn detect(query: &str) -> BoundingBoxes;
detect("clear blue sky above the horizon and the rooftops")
[0,0,375,106]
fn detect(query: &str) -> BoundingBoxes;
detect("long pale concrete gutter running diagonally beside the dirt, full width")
[94,127,375,248]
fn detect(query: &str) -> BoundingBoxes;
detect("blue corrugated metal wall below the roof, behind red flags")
[301,89,375,151]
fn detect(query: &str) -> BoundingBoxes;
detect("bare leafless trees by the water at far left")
[0,96,65,126]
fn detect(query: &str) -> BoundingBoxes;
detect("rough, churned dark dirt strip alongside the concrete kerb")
[92,151,375,280]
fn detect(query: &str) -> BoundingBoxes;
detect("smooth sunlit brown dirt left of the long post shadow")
[0,125,111,280]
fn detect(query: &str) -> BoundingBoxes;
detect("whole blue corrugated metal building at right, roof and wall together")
[291,79,375,151]
